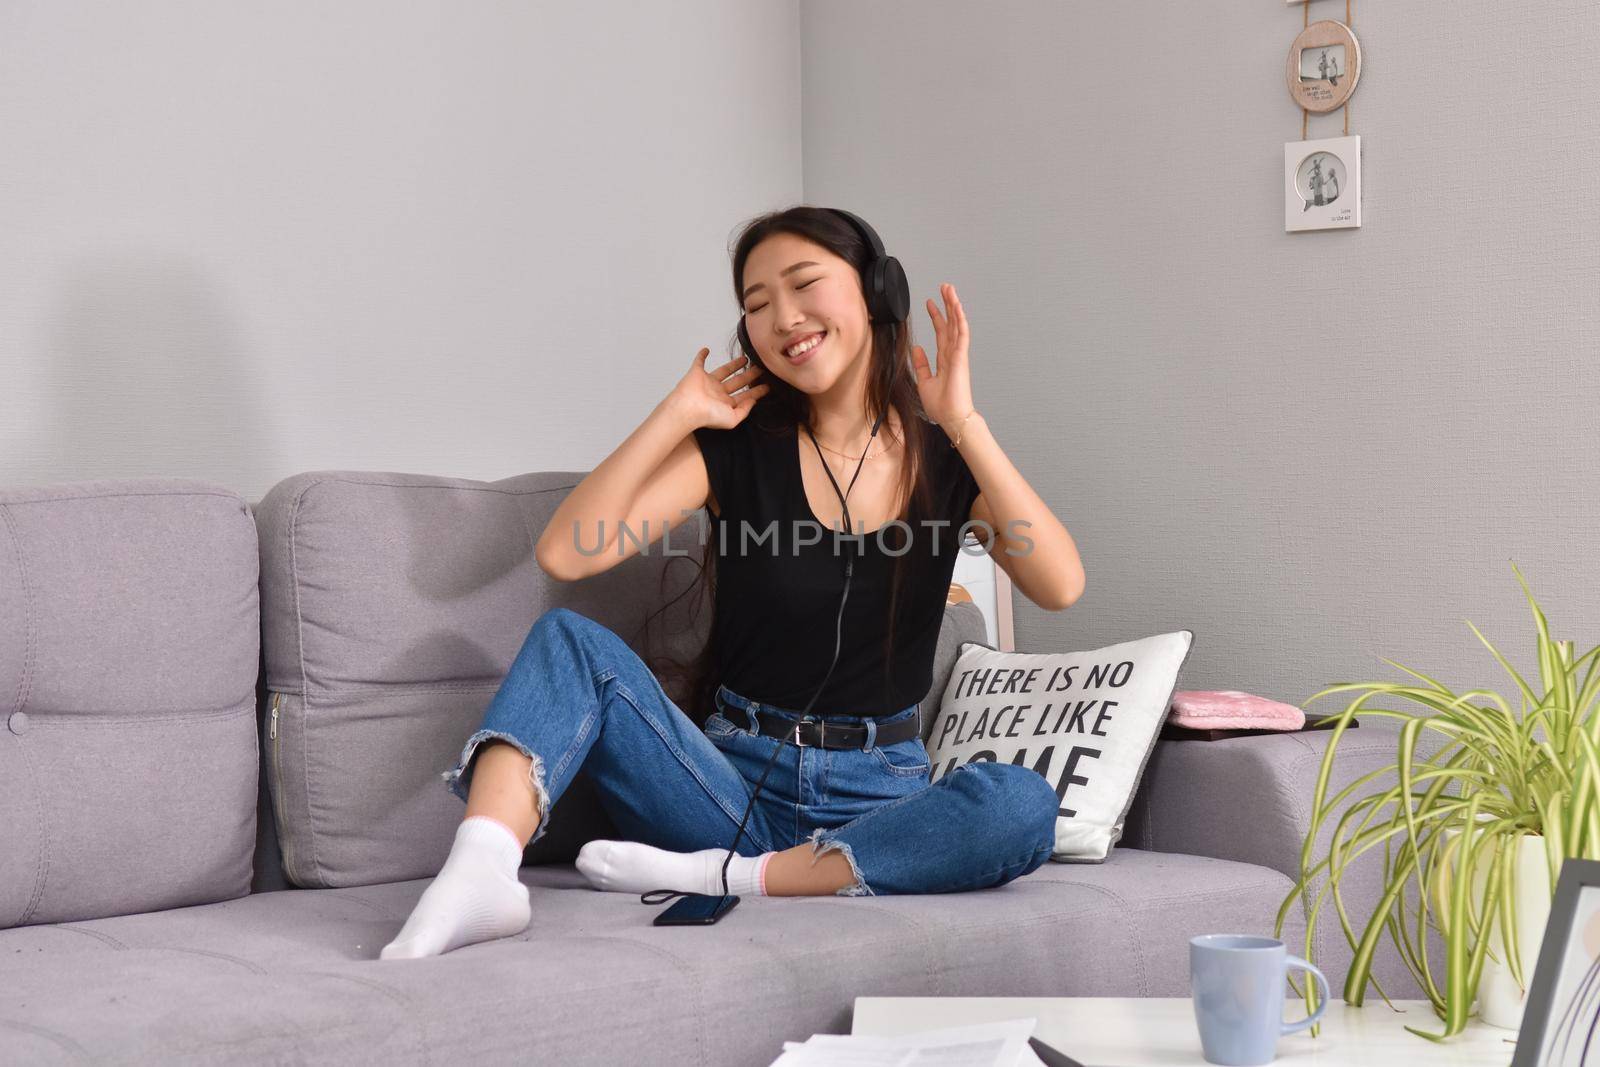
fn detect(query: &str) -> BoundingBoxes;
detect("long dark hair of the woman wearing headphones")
[642,205,933,726]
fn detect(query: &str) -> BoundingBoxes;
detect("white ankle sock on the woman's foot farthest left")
[378,816,533,960]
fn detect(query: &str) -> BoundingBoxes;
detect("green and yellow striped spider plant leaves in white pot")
[1274,563,1600,1041]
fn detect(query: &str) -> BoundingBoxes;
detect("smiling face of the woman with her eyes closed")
[741,234,872,395]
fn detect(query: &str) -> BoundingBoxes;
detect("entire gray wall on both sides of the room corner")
[0,0,1600,710]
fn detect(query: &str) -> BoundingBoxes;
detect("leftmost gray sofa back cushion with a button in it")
[0,478,259,926]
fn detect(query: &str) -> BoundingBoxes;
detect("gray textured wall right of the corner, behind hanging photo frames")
[802,0,1600,703]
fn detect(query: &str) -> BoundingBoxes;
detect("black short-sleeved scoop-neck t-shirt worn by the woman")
[694,403,979,717]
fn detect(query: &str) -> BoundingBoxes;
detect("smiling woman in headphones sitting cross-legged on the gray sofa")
[381,206,1083,960]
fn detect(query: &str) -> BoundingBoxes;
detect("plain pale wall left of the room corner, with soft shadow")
[0,0,802,499]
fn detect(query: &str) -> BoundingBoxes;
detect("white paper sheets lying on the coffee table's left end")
[771,1016,1040,1067]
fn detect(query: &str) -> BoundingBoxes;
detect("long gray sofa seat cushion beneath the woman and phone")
[0,844,1298,1067]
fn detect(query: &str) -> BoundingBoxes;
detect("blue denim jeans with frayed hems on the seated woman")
[442,608,1059,896]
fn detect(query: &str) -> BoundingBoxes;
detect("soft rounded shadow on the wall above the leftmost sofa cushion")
[12,251,278,499]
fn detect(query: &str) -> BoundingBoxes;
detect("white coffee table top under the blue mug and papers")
[850,997,1517,1067]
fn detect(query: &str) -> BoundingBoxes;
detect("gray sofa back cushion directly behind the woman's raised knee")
[256,470,710,888]
